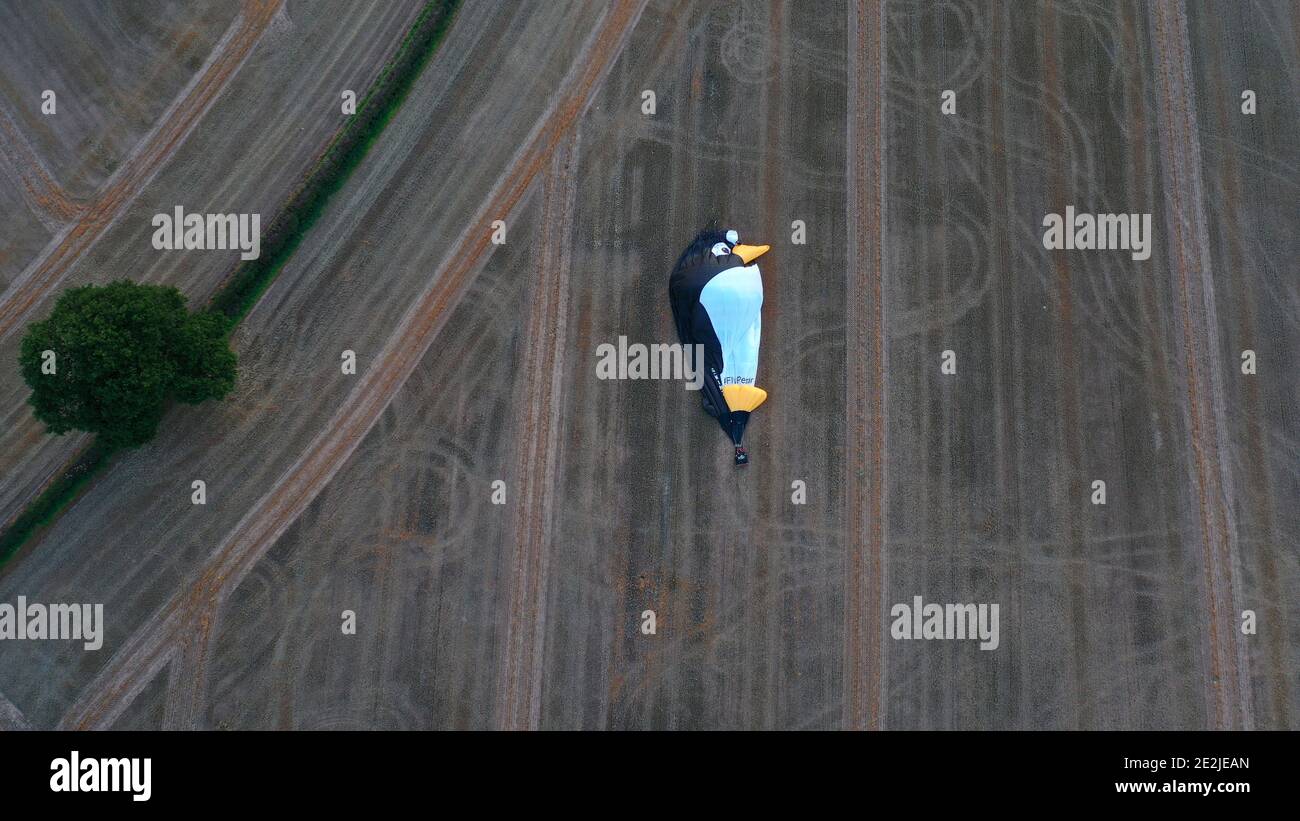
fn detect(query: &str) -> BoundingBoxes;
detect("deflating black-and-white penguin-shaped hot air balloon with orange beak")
[668,231,770,465]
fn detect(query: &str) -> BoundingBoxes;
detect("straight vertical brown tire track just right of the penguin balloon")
[842,0,885,730]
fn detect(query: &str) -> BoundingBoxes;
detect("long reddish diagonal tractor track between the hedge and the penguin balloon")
[60,0,646,729]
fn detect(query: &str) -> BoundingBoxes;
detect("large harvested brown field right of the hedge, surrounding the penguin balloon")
[0,0,1300,729]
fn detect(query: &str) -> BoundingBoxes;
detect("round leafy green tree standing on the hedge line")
[18,281,235,448]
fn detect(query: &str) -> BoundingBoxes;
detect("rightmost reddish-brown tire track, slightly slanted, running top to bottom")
[1148,0,1255,729]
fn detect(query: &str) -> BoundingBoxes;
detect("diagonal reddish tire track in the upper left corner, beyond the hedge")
[0,0,281,339]
